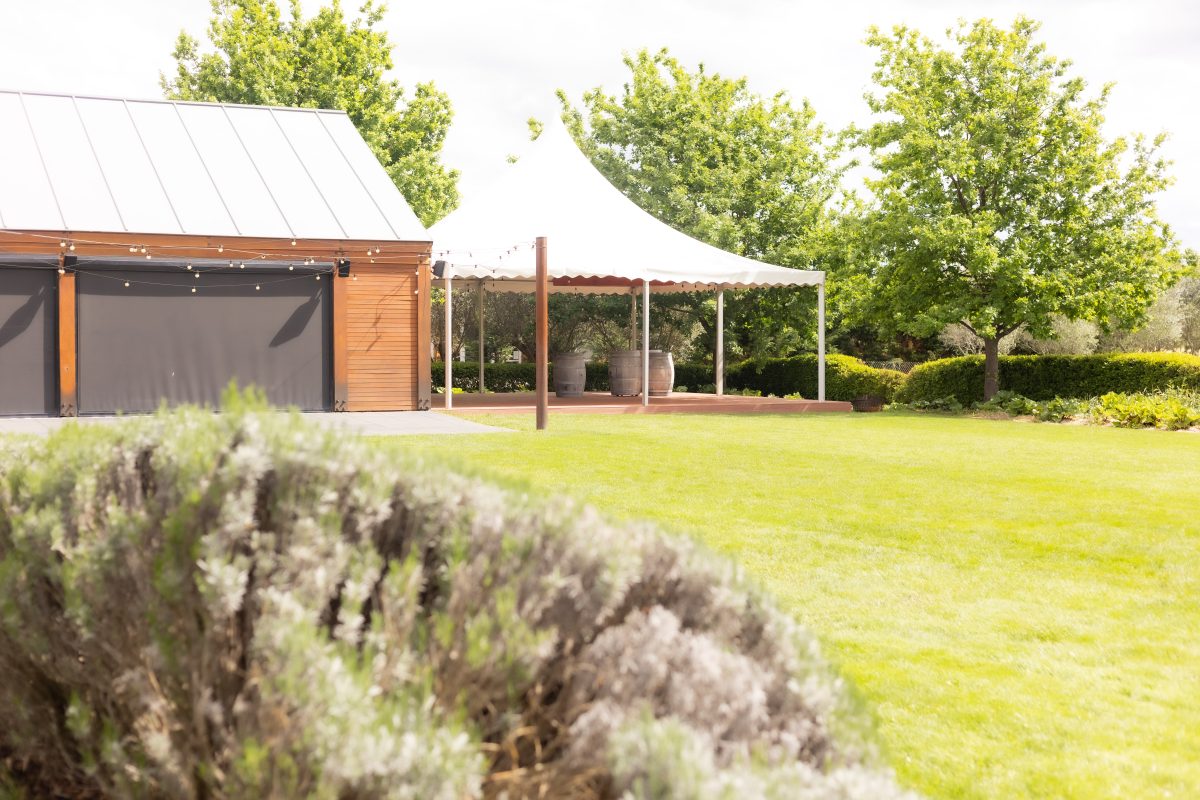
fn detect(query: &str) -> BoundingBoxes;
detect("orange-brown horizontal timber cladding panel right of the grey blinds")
[337,260,428,411]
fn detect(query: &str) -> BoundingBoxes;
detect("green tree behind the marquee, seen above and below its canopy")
[559,49,844,355]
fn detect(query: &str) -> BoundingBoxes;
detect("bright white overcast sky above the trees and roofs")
[0,0,1200,248]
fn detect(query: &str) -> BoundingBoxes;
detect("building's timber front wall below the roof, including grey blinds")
[0,231,431,416]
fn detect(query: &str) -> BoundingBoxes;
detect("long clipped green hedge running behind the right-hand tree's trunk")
[896,353,1200,405]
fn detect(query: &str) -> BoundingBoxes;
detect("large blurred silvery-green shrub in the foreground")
[0,398,904,800]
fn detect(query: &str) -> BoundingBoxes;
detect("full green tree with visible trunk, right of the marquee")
[862,18,1182,397]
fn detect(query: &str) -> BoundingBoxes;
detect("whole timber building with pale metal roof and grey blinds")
[0,91,431,415]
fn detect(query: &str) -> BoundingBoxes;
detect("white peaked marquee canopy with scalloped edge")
[430,119,824,291]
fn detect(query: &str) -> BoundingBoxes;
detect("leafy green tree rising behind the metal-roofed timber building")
[160,0,458,225]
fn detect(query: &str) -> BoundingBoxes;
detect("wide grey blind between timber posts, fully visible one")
[77,270,331,414]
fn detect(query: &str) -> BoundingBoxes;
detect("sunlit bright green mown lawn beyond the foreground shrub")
[380,413,1200,798]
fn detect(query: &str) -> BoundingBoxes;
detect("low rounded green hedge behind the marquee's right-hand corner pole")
[725,354,905,403]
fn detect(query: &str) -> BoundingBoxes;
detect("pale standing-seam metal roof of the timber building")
[0,91,428,241]
